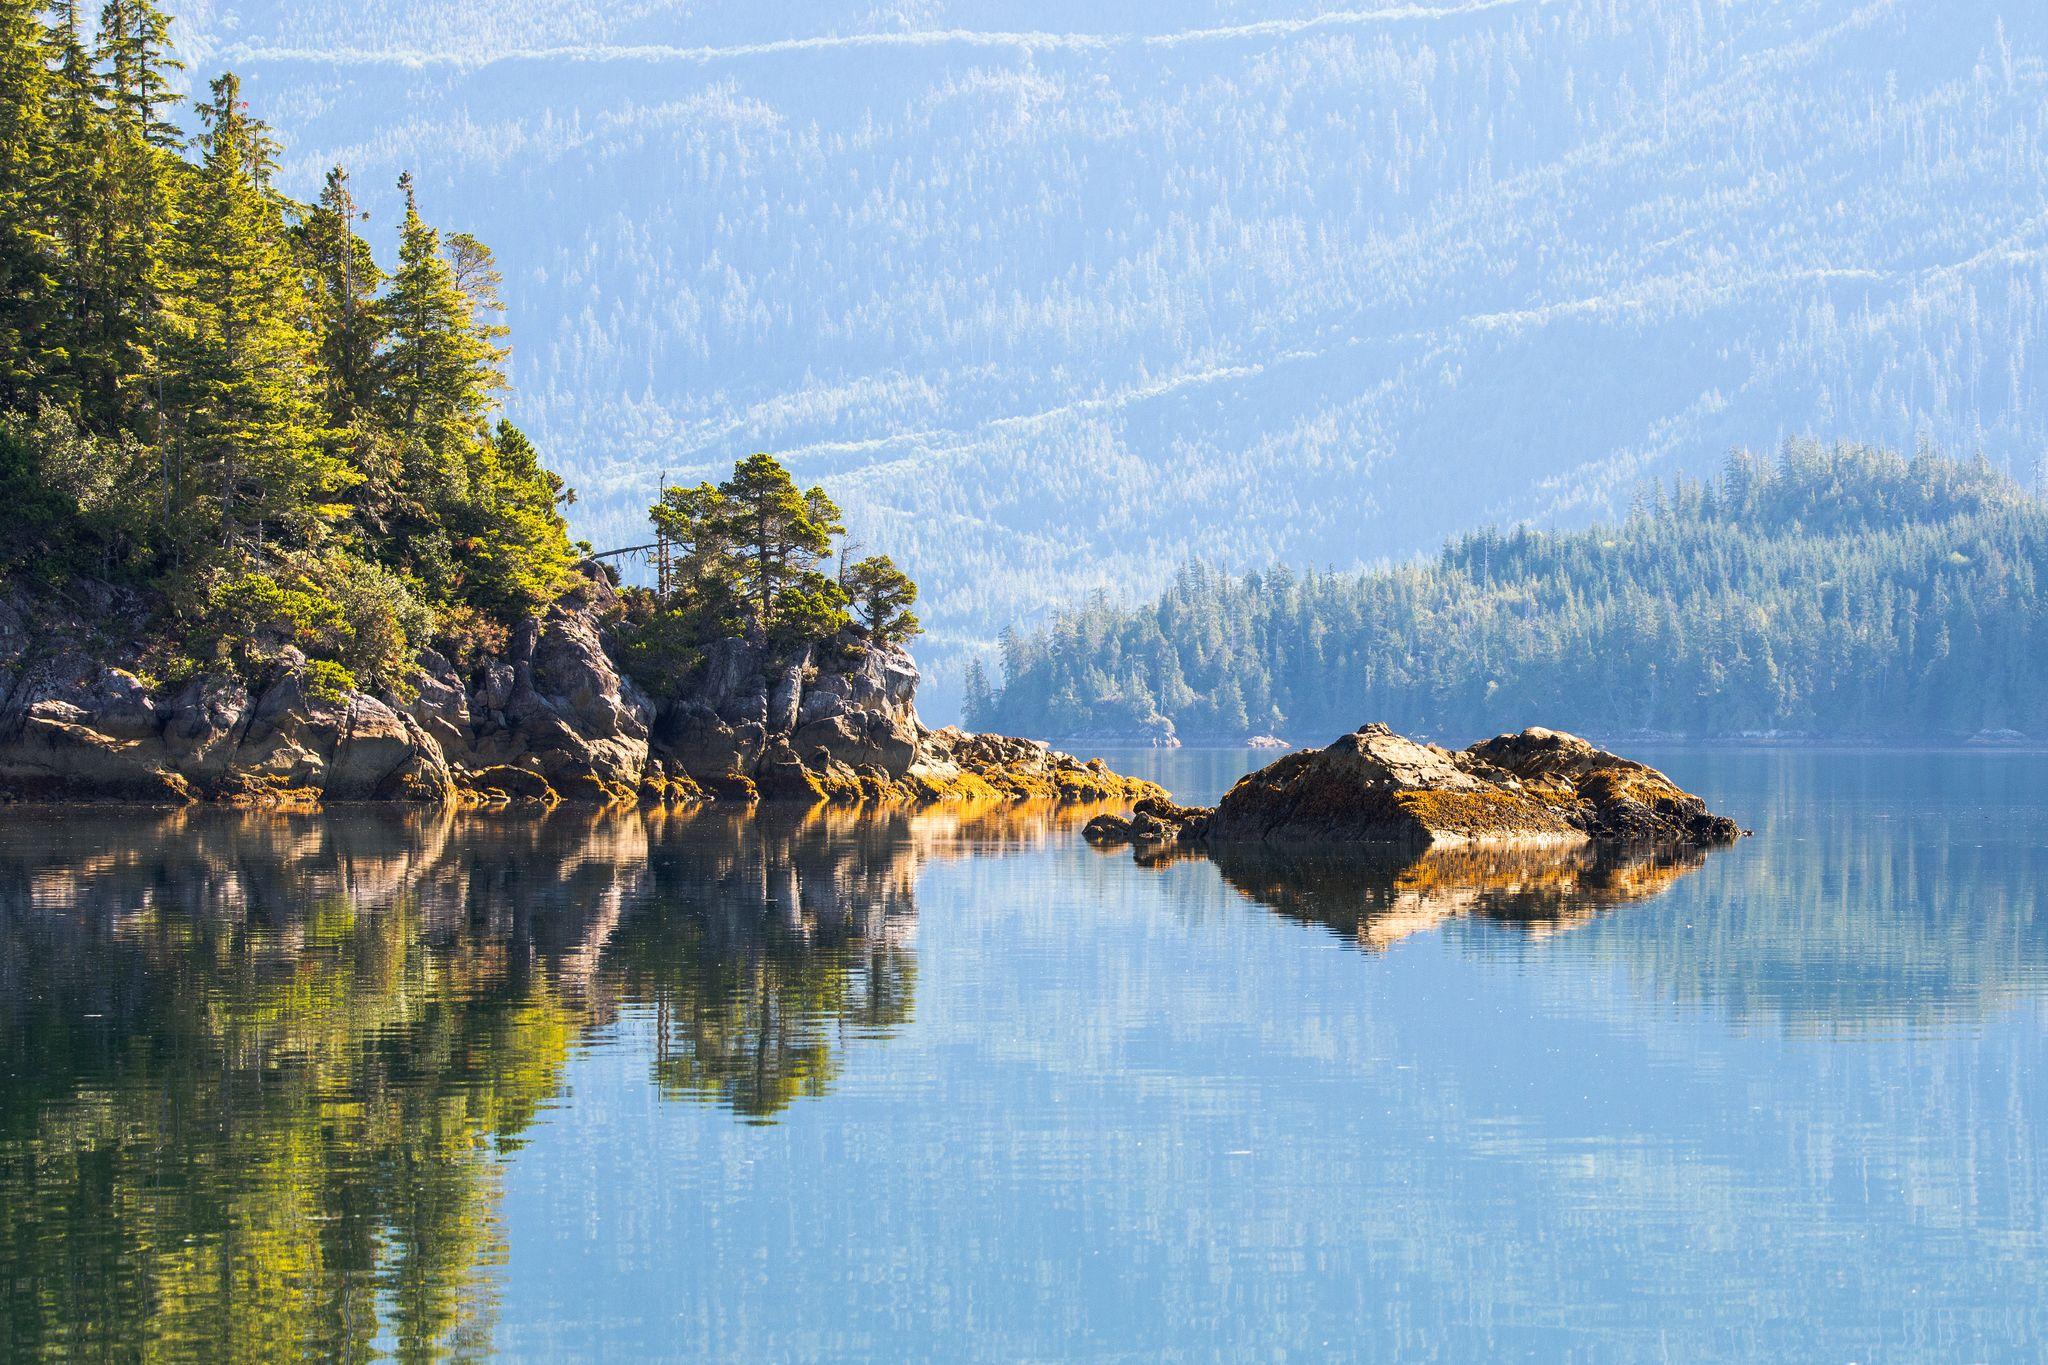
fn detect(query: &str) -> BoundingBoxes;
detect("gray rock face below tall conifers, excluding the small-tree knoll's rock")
[0,573,655,800]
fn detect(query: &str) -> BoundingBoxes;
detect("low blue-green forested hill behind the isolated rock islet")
[969,442,2048,743]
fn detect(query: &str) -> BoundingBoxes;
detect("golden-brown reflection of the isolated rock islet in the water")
[1204,845,1706,952]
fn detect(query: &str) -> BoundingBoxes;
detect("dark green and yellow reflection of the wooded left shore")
[0,812,1089,1359]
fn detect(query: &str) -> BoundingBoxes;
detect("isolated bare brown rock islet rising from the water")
[1083,724,1743,849]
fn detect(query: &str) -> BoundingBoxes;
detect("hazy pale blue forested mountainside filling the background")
[178,0,2048,699]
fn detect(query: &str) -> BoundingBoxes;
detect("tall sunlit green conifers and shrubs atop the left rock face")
[0,0,575,690]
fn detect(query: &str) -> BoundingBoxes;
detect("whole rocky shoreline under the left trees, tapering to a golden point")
[0,567,1165,806]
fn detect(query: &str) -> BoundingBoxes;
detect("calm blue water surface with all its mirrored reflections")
[0,753,2048,1361]
